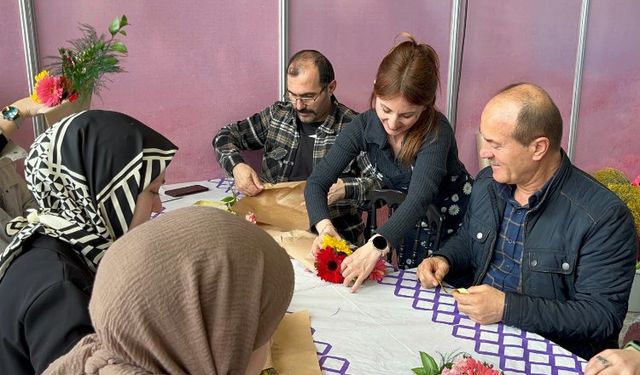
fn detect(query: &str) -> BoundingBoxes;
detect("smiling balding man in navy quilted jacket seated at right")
[418,84,637,359]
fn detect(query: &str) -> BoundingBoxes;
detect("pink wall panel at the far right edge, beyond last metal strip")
[575,0,640,179]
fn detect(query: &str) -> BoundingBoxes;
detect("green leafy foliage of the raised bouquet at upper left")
[49,15,129,100]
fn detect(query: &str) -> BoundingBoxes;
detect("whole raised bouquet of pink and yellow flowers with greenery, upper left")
[31,15,129,107]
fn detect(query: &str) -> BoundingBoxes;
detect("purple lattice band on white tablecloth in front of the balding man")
[380,270,585,375]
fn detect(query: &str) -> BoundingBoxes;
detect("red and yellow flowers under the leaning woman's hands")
[315,234,386,284]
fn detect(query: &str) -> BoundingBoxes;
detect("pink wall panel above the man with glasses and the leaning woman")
[289,0,451,111]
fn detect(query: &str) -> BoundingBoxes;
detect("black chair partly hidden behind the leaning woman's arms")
[365,189,444,262]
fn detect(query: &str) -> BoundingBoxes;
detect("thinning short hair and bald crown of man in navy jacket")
[496,82,562,151]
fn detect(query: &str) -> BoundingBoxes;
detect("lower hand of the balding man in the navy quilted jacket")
[453,285,505,324]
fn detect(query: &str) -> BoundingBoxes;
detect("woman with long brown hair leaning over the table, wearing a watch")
[305,35,472,291]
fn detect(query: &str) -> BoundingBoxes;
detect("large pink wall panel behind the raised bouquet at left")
[24,0,278,183]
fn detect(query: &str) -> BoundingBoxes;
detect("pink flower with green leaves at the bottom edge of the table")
[411,352,504,375]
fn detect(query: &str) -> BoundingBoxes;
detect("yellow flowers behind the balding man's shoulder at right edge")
[593,168,640,264]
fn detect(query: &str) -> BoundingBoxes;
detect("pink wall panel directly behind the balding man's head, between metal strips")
[456,0,580,173]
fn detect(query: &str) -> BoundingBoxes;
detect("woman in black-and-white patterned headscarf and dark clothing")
[0,111,177,375]
